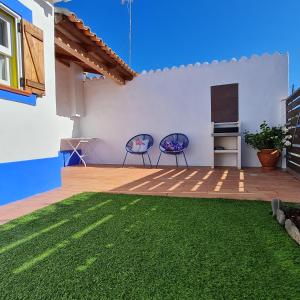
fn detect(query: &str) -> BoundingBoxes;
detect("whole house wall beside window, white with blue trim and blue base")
[0,0,61,205]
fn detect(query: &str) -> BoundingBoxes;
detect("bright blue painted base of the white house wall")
[0,157,61,205]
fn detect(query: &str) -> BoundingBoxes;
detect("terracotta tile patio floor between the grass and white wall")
[0,166,300,224]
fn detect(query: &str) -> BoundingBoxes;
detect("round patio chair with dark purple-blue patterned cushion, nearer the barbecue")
[156,133,189,168]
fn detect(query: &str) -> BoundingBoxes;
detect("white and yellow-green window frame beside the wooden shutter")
[0,3,23,89]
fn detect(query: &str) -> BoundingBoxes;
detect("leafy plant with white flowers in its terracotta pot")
[244,121,292,170]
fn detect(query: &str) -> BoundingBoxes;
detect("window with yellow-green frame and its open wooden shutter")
[0,3,45,96]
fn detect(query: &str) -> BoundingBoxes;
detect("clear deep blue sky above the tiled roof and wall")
[59,0,300,87]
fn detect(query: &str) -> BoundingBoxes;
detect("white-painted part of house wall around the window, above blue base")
[0,0,59,162]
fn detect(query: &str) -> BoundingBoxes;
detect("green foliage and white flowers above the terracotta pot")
[244,121,292,151]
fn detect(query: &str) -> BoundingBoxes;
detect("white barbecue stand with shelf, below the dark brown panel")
[211,122,241,169]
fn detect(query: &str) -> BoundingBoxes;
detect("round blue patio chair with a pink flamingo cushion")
[123,133,153,167]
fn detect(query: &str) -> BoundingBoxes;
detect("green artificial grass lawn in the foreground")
[0,193,300,300]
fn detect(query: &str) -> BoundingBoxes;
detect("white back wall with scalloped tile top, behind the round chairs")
[80,54,288,166]
